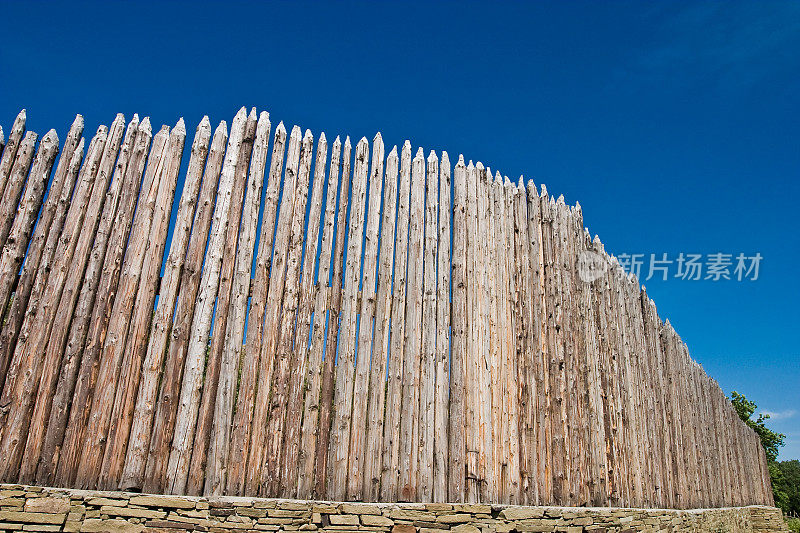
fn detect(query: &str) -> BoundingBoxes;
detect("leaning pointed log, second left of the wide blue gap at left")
[76,120,169,488]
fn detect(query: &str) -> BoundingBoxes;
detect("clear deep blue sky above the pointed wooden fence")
[0,1,800,459]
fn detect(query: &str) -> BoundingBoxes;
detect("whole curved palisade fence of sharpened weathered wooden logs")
[0,108,772,508]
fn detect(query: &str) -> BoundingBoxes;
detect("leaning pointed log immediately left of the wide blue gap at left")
[98,118,186,488]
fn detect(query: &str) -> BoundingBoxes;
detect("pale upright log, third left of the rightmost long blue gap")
[397,148,425,501]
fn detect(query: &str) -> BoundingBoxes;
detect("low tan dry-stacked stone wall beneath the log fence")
[0,484,786,533]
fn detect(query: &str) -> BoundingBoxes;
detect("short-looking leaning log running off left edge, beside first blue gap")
[0,130,58,320]
